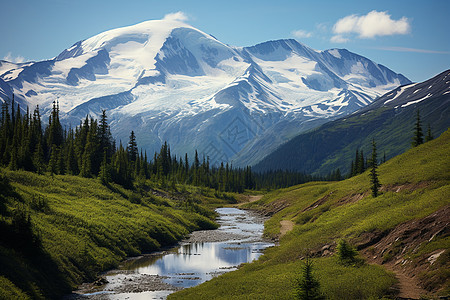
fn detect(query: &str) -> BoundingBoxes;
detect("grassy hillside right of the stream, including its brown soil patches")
[170,131,450,299]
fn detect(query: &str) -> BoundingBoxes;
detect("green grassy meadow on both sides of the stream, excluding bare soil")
[0,132,450,299]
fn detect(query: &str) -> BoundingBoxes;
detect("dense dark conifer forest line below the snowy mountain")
[0,97,348,193]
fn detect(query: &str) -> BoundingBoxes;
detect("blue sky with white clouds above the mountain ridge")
[0,0,450,81]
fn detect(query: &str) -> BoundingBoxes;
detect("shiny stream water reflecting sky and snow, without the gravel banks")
[100,208,273,299]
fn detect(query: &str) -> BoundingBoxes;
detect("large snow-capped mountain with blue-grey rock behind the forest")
[0,20,410,165]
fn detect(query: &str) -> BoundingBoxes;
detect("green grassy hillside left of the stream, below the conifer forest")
[0,170,229,299]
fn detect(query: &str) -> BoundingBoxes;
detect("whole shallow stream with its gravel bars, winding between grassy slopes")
[72,208,273,300]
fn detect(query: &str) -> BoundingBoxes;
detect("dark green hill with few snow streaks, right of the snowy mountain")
[253,70,450,174]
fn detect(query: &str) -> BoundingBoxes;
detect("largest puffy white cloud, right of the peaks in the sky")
[333,10,411,38]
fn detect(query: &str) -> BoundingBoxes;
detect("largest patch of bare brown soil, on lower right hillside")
[358,205,450,299]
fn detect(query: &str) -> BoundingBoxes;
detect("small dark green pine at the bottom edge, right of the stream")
[296,257,325,300]
